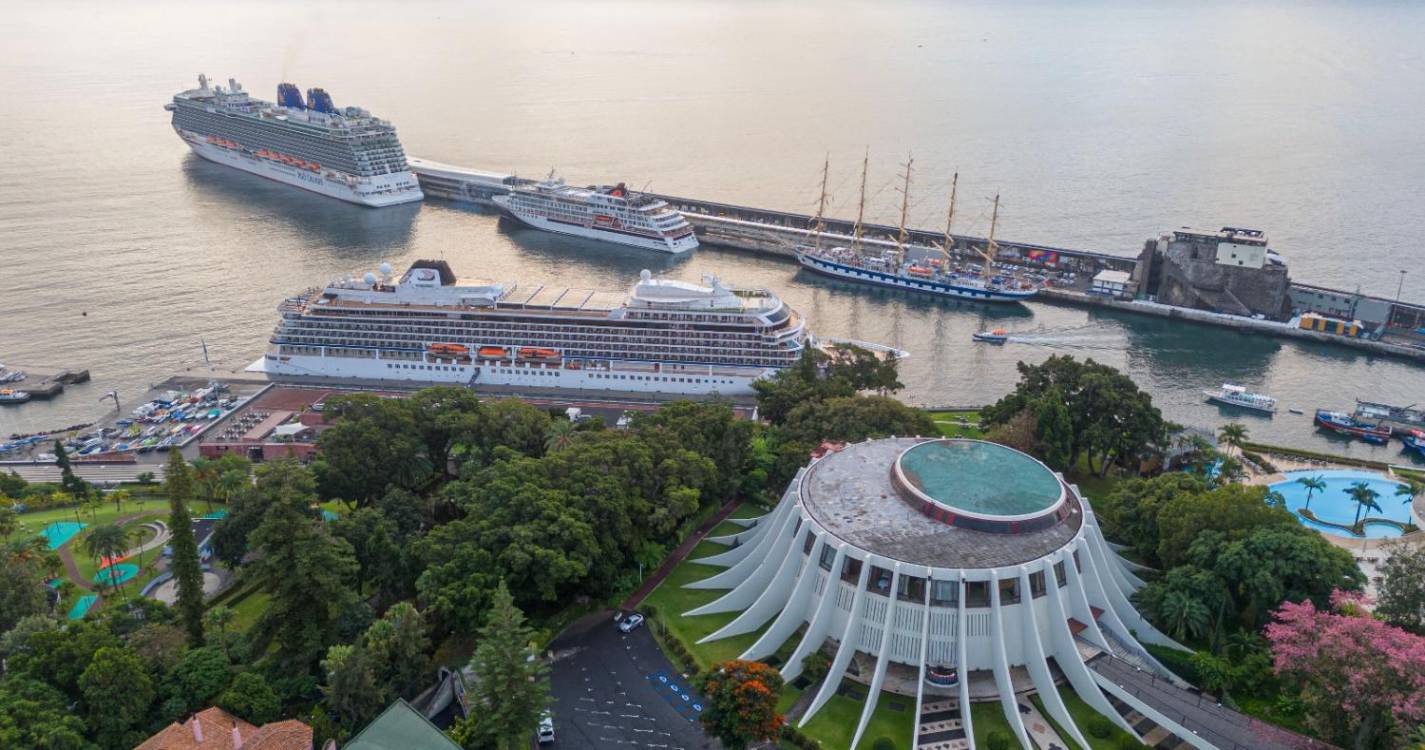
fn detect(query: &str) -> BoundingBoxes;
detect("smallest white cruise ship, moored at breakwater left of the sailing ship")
[492,173,698,252]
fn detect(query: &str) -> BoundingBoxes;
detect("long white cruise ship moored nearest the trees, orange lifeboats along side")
[248,261,903,395]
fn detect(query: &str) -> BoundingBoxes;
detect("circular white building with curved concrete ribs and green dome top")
[685,438,1214,749]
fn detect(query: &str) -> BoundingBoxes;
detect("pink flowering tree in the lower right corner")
[1267,592,1425,750]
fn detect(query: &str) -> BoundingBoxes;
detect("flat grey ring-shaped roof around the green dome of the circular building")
[799,438,1083,569]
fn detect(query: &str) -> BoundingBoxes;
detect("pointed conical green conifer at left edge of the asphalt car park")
[452,582,549,750]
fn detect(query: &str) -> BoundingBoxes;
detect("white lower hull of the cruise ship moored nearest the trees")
[247,351,775,396]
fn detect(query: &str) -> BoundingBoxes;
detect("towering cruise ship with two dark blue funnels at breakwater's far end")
[164,76,422,207]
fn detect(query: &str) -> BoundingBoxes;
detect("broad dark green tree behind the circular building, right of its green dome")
[980,355,1170,473]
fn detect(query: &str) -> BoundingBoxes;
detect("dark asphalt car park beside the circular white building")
[544,612,721,750]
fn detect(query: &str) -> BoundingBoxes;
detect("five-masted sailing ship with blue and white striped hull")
[797,155,1039,302]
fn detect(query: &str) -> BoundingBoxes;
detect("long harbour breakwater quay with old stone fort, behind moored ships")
[410,158,1425,361]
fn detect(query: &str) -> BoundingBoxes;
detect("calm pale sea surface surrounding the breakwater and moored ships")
[0,0,1425,458]
